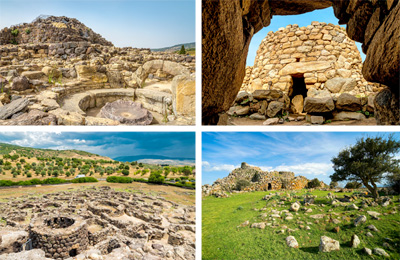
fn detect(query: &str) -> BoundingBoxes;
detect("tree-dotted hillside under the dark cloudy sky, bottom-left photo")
[0,143,195,181]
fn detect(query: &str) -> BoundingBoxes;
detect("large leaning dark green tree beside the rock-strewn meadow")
[330,135,400,199]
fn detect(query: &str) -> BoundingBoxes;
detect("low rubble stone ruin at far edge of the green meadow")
[202,162,308,197]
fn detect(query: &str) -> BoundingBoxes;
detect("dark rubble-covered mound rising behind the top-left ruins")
[0,15,113,46]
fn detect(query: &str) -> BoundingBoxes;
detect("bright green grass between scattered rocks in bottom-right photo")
[202,191,400,260]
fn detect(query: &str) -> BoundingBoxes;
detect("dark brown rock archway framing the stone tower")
[202,0,400,124]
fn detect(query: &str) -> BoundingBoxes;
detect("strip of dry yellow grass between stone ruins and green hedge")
[0,181,195,206]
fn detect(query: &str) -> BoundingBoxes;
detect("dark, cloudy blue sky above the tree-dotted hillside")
[0,132,195,158]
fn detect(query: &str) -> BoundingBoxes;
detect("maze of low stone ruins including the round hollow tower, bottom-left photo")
[0,187,195,260]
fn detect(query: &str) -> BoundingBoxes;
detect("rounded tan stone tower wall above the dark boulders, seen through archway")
[241,22,379,97]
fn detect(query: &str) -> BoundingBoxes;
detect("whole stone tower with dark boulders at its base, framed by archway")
[227,22,385,124]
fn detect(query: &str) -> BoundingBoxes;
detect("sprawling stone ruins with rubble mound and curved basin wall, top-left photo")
[0,16,195,125]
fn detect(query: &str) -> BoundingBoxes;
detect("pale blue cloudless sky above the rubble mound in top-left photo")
[0,0,195,48]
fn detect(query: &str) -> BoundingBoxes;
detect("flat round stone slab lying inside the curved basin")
[99,100,153,125]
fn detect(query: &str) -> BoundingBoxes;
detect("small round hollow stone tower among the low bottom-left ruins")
[29,216,89,259]
